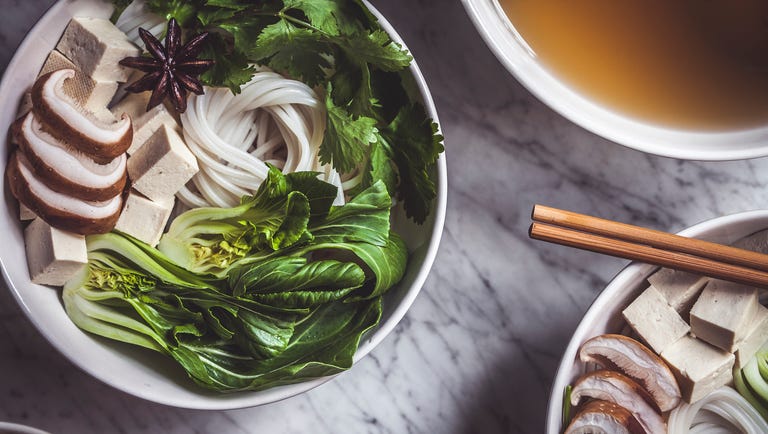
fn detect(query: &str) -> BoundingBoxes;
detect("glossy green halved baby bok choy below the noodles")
[63,168,407,391]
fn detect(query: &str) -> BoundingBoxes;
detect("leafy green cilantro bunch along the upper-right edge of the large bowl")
[118,0,443,223]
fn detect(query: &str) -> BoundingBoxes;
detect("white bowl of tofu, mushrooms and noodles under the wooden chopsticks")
[546,211,768,434]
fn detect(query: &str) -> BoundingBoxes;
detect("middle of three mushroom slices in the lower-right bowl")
[571,370,667,434]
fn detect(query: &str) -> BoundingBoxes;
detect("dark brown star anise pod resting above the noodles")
[120,18,214,113]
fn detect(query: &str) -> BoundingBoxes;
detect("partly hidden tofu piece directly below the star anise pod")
[112,92,181,155]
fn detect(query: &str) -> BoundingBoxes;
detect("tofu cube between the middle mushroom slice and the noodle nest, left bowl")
[128,125,198,202]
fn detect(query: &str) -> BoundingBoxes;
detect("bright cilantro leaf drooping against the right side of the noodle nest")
[320,84,378,173]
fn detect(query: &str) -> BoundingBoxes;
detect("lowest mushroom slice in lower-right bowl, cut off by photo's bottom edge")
[563,399,646,434]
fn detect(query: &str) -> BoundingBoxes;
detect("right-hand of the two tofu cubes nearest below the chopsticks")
[691,279,760,352]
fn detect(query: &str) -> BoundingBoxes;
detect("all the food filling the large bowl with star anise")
[6,0,442,391]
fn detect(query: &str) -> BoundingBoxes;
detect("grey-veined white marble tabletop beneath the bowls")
[0,0,768,434]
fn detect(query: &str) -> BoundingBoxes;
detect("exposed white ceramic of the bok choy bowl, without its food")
[0,0,447,409]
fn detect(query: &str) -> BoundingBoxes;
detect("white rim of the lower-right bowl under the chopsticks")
[546,210,768,434]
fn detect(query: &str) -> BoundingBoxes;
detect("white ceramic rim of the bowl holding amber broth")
[462,0,768,160]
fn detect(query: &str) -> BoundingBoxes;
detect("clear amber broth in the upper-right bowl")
[499,0,768,130]
